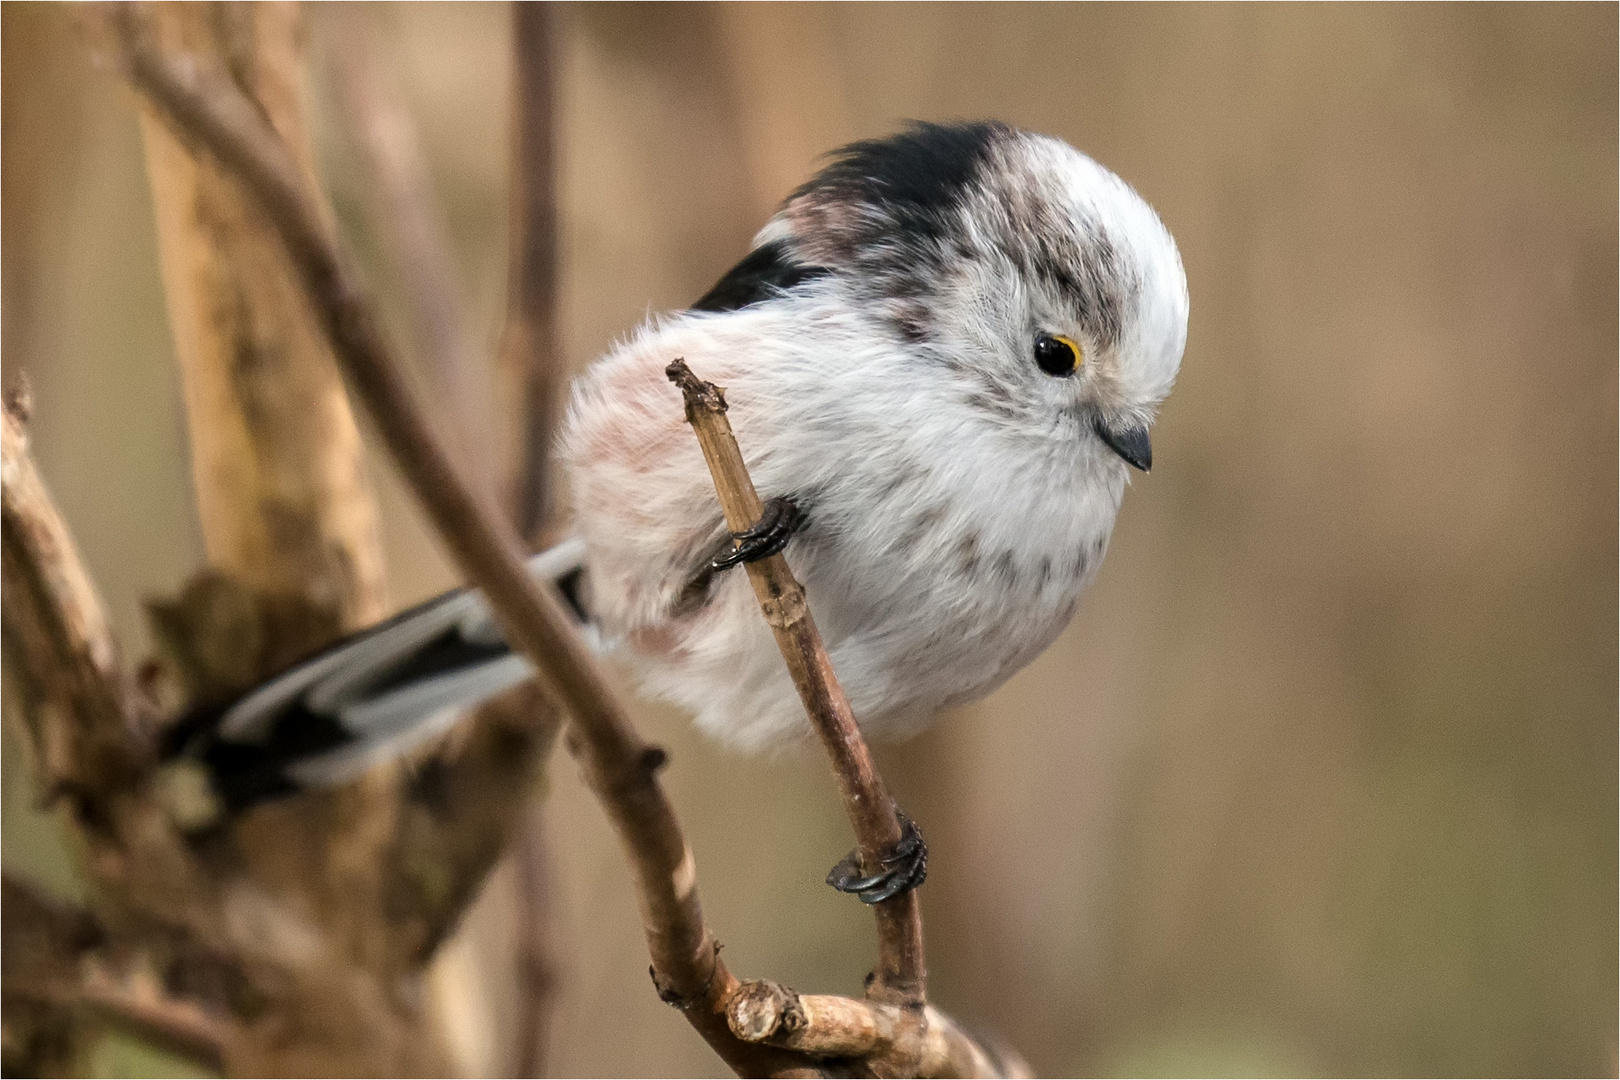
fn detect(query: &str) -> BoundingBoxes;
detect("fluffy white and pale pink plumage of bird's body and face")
[564,127,1187,748]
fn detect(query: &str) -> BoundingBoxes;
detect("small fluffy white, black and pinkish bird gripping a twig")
[170,120,1189,902]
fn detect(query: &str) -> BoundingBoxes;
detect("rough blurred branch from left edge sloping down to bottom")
[0,341,456,1075]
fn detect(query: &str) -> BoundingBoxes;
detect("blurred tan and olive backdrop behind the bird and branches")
[0,3,1620,1075]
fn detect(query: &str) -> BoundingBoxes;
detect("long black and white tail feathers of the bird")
[167,541,585,810]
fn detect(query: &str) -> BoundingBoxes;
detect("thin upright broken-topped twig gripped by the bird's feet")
[667,359,927,1006]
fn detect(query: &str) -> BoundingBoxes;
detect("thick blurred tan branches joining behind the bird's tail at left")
[3,5,557,1075]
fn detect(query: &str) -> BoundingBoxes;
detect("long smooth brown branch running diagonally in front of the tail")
[109,19,810,1075]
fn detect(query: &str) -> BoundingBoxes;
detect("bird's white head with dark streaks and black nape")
[755,123,1187,470]
